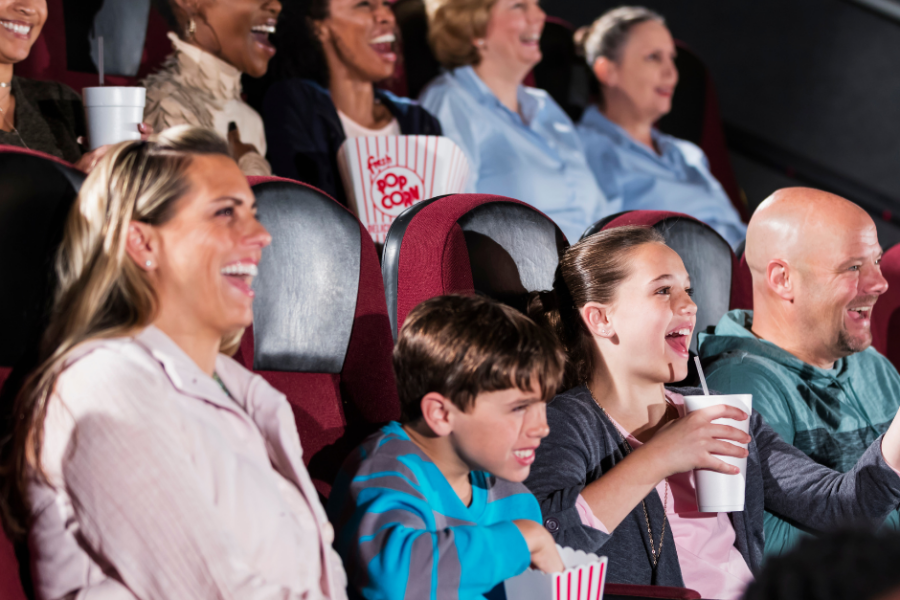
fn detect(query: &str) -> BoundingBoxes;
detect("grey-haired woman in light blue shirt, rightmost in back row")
[578,7,747,247]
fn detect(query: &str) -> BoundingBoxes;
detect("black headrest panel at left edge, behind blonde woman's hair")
[0,148,84,366]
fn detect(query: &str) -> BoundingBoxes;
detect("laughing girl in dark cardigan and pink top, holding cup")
[526,227,900,599]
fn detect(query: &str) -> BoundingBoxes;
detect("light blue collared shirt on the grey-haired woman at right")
[578,106,747,247]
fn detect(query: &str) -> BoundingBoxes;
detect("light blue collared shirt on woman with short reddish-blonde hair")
[420,67,611,243]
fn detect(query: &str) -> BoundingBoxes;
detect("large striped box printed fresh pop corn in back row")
[338,135,469,244]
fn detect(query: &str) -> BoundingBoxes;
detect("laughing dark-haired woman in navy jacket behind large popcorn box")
[262,0,441,204]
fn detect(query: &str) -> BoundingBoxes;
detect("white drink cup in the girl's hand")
[684,394,753,512]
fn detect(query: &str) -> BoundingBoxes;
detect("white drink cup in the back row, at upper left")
[84,86,147,150]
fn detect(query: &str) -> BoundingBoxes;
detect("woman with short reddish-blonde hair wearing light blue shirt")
[420,0,610,242]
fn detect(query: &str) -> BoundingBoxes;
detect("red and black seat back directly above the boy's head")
[382,194,568,335]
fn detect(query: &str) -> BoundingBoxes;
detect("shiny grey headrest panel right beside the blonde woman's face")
[253,181,361,373]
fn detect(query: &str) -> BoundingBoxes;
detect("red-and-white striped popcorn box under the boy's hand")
[504,545,608,600]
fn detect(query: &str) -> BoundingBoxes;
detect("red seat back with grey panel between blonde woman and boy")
[236,177,400,495]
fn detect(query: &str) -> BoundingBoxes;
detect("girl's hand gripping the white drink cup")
[638,404,751,480]
